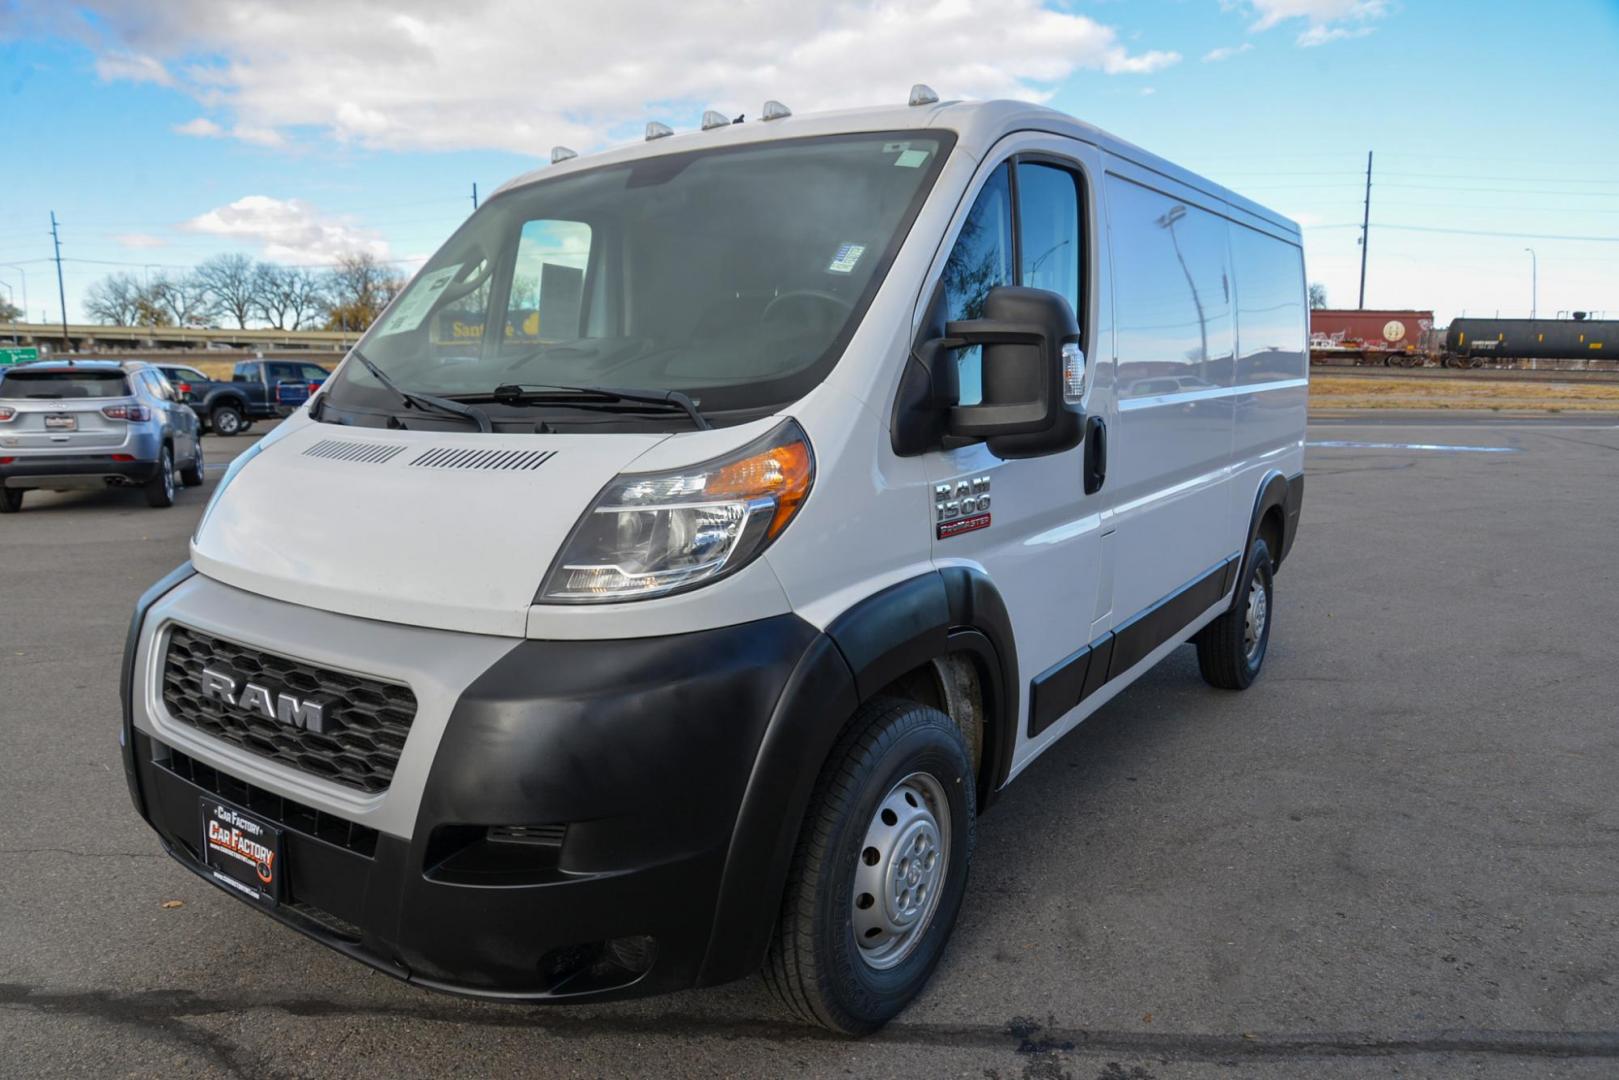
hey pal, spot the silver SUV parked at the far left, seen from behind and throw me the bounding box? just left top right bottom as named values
left=0, top=359, right=202, bottom=513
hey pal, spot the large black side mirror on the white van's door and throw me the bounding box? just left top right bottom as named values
left=929, top=285, right=1085, bottom=458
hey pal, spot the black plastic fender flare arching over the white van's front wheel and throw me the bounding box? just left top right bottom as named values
left=696, top=567, right=1018, bottom=986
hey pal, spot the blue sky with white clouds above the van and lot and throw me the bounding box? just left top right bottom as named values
left=0, top=0, right=1619, bottom=324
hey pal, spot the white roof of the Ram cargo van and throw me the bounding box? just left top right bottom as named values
left=495, top=100, right=1298, bottom=238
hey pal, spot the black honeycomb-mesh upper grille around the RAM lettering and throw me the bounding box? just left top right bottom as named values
left=164, top=627, right=416, bottom=792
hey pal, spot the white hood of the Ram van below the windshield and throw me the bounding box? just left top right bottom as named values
left=191, top=419, right=669, bottom=636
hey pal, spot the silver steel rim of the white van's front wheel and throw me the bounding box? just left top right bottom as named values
left=850, top=772, right=950, bottom=972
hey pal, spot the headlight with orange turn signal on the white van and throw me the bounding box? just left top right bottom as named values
left=538, top=421, right=814, bottom=604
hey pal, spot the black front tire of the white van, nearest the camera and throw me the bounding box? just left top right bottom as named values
left=764, top=699, right=978, bottom=1035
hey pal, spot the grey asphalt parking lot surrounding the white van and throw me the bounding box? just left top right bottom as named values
left=0, top=416, right=1619, bottom=1080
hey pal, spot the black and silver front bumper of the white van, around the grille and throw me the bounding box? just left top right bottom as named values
left=123, top=578, right=848, bottom=999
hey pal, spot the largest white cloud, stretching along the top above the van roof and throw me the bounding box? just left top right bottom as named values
left=57, top=0, right=1180, bottom=154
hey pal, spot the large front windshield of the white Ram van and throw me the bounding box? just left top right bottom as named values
left=327, top=131, right=950, bottom=423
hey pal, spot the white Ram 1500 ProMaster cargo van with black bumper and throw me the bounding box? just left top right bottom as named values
left=123, top=92, right=1307, bottom=1033
